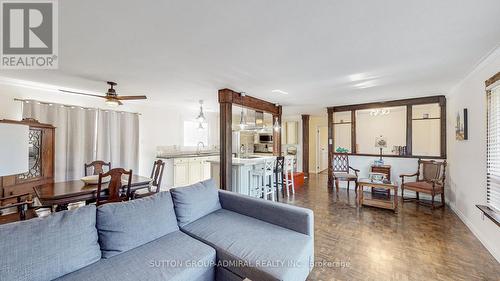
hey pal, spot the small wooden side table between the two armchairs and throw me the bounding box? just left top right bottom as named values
left=358, top=179, right=398, bottom=213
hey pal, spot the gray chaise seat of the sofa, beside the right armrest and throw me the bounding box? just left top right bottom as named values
left=181, top=209, right=314, bottom=280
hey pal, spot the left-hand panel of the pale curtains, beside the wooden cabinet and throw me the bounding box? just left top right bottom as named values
left=23, top=101, right=97, bottom=181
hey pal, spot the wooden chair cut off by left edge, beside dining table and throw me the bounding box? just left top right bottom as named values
left=0, top=193, right=36, bottom=224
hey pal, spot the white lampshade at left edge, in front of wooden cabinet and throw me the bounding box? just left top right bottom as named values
left=0, top=123, right=29, bottom=177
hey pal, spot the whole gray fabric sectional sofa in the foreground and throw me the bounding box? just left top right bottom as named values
left=0, top=180, right=314, bottom=281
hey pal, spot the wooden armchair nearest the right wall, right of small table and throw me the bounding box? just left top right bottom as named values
left=399, top=160, right=446, bottom=209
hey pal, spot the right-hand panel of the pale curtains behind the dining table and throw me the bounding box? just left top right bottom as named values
left=97, top=109, right=139, bottom=174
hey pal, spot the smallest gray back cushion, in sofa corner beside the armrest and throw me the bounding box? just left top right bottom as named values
left=171, top=179, right=221, bottom=227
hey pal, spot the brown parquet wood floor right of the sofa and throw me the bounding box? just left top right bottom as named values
left=284, top=174, right=500, bottom=281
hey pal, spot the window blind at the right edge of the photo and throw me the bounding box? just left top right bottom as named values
left=486, top=86, right=500, bottom=211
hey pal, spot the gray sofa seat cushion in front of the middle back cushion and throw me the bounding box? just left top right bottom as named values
left=57, top=231, right=215, bottom=281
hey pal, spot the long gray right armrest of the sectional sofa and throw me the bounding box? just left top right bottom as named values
left=219, top=190, right=314, bottom=236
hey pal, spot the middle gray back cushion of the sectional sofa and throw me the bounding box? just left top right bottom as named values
left=96, top=192, right=179, bottom=258
